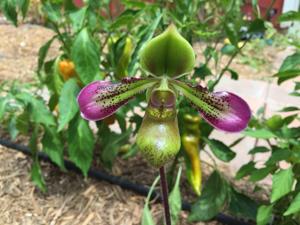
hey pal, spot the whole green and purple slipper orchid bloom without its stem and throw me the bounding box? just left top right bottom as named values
left=78, top=25, right=251, bottom=167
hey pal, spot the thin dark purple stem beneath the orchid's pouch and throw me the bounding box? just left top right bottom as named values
left=159, top=166, right=171, bottom=225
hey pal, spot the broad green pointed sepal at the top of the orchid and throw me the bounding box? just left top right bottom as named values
left=140, top=24, right=195, bottom=77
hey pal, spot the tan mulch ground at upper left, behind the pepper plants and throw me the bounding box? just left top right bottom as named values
left=0, top=24, right=58, bottom=82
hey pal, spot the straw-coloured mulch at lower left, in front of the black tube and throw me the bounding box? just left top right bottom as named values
left=0, top=144, right=220, bottom=225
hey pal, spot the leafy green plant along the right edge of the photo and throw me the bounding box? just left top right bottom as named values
left=236, top=12, right=300, bottom=225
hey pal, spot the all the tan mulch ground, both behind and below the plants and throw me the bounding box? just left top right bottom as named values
left=0, top=17, right=287, bottom=225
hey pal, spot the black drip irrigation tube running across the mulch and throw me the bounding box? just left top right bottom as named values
left=0, top=138, right=255, bottom=225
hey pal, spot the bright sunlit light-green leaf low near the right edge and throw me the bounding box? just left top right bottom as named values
left=271, top=167, right=294, bottom=203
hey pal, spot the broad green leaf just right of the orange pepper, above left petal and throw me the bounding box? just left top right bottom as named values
left=71, top=28, right=100, bottom=84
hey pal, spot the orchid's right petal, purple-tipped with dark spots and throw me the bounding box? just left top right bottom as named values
left=174, top=81, right=251, bottom=132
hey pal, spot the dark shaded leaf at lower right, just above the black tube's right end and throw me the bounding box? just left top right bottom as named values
left=229, top=188, right=258, bottom=220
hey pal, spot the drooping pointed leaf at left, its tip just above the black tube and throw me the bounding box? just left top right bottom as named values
left=42, top=127, right=65, bottom=170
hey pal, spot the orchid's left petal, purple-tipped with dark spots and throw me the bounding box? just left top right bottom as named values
left=77, top=78, right=155, bottom=121
